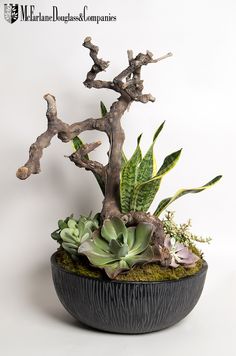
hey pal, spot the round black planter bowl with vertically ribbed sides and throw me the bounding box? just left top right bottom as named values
left=51, top=253, right=207, bottom=334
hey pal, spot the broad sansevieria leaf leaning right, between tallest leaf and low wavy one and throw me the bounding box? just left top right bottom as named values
left=131, top=150, right=181, bottom=211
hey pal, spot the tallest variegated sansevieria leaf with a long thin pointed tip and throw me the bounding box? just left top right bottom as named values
left=137, top=121, right=165, bottom=183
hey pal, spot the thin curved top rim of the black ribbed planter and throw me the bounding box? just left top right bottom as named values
left=50, top=251, right=208, bottom=285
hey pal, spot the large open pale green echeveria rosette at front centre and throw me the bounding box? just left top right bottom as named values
left=78, top=217, right=153, bottom=278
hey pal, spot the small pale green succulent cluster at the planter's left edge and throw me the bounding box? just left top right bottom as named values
left=51, top=215, right=99, bottom=259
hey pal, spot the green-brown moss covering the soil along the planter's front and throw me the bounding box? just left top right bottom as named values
left=56, top=247, right=203, bottom=281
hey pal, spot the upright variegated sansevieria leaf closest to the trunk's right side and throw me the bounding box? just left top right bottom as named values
left=120, top=135, right=142, bottom=213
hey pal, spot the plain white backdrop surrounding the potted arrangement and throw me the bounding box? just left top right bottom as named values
left=0, top=0, right=236, bottom=356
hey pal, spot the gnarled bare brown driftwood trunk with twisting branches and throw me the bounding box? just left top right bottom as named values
left=17, top=37, right=171, bottom=225
